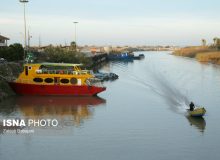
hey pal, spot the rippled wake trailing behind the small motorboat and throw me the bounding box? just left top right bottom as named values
left=111, top=64, right=190, bottom=114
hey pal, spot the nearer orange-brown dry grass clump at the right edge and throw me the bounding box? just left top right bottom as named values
left=196, top=51, right=220, bottom=64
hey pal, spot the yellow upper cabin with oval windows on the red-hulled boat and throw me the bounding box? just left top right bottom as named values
left=16, top=63, right=94, bottom=85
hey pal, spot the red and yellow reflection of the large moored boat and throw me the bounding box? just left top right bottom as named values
left=0, top=96, right=106, bottom=133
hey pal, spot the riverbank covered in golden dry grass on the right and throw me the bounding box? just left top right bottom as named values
left=173, top=46, right=220, bottom=65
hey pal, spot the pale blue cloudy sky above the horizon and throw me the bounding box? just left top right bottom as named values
left=0, top=0, right=220, bottom=46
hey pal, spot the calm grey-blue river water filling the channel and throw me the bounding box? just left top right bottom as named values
left=0, top=52, right=220, bottom=160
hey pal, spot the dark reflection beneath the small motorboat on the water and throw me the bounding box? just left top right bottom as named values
left=186, top=116, right=206, bottom=132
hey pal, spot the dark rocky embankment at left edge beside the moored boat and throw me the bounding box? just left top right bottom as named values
left=0, top=62, right=22, bottom=102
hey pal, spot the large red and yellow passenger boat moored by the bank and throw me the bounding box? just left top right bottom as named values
left=9, top=63, right=106, bottom=96
